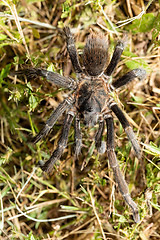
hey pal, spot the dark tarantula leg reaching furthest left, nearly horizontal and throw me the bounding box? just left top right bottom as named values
left=11, top=68, right=77, bottom=90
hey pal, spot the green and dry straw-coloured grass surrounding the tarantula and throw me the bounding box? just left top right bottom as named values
left=0, top=0, right=160, bottom=240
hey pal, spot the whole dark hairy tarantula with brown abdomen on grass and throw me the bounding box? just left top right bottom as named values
left=16, top=27, right=146, bottom=222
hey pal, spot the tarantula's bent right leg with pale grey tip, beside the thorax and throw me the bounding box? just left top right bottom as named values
left=112, top=68, right=146, bottom=89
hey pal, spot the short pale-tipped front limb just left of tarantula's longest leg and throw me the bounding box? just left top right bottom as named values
left=95, top=118, right=106, bottom=154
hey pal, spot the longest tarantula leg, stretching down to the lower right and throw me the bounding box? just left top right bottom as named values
left=105, top=114, right=140, bottom=223
